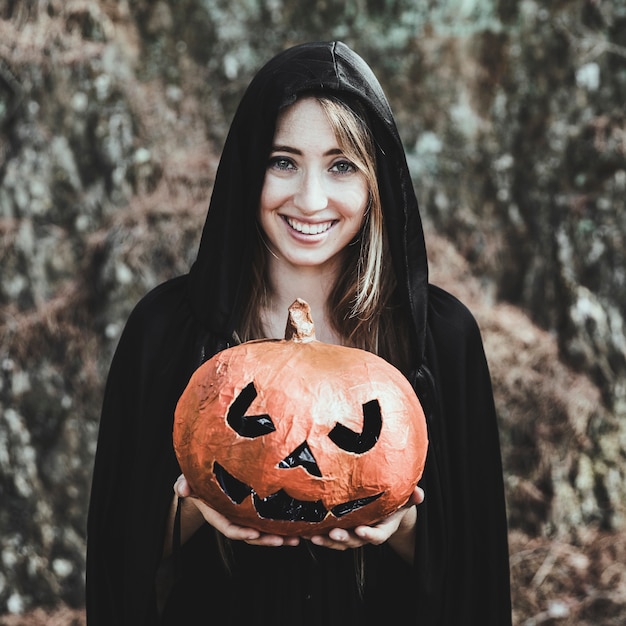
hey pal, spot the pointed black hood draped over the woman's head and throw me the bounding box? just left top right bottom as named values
left=189, top=42, right=428, bottom=366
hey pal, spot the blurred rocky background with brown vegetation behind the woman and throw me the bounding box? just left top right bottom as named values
left=0, top=0, right=626, bottom=626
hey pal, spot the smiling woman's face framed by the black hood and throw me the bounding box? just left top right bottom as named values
left=259, top=98, right=369, bottom=268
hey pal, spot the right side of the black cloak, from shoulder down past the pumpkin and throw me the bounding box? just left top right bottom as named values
left=415, top=285, right=511, bottom=626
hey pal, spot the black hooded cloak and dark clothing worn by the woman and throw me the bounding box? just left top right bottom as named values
left=86, top=43, right=511, bottom=626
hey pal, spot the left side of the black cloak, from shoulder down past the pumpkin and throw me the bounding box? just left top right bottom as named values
left=86, top=276, right=202, bottom=626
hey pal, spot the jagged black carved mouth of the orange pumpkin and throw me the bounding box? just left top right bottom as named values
left=213, top=462, right=383, bottom=523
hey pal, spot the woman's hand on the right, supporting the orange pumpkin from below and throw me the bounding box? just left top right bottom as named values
left=304, top=487, right=424, bottom=563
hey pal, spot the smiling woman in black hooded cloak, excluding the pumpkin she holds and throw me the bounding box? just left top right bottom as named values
left=87, top=42, right=511, bottom=626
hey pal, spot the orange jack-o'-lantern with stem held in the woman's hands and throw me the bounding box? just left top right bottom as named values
left=173, top=300, right=428, bottom=537
